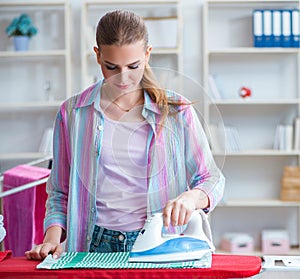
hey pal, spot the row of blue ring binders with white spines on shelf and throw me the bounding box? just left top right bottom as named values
left=252, top=9, right=300, bottom=48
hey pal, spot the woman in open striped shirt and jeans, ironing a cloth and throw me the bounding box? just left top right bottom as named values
left=26, top=11, right=224, bottom=259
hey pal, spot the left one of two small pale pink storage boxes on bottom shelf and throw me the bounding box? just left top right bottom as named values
left=221, top=233, right=254, bottom=254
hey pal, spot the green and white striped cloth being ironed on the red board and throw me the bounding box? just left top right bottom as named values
left=37, top=252, right=212, bottom=269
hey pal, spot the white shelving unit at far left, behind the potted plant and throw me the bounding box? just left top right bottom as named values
left=0, top=1, right=72, bottom=173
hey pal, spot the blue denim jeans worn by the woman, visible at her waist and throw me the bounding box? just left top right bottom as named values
left=90, top=225, right=140, bottom=253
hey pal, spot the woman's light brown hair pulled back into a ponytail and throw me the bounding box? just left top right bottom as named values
left=96, top=10, right=186, bottom=124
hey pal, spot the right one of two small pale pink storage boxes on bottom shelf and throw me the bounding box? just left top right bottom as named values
left=262, top=230, right=290, bottom=254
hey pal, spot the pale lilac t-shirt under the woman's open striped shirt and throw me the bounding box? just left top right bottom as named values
left=96, top=117, right=149, bottom=231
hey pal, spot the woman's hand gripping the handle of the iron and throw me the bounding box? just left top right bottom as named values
left=163, top=189, right=209, bottom=230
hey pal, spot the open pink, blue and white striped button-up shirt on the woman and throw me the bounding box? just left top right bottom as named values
left=44, top=81, right=225, bottom=251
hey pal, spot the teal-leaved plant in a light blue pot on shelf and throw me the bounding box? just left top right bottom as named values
left=6, top=14, right=38, bottom=51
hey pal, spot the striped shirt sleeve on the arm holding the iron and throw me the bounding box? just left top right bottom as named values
left=184, top=106, right=225, bottom=211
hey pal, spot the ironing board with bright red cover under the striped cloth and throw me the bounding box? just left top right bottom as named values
left=0, top=254, right=261, bottom=279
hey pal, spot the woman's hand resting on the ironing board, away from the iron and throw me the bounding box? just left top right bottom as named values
left=25, top=242, right=63, bottom=260
